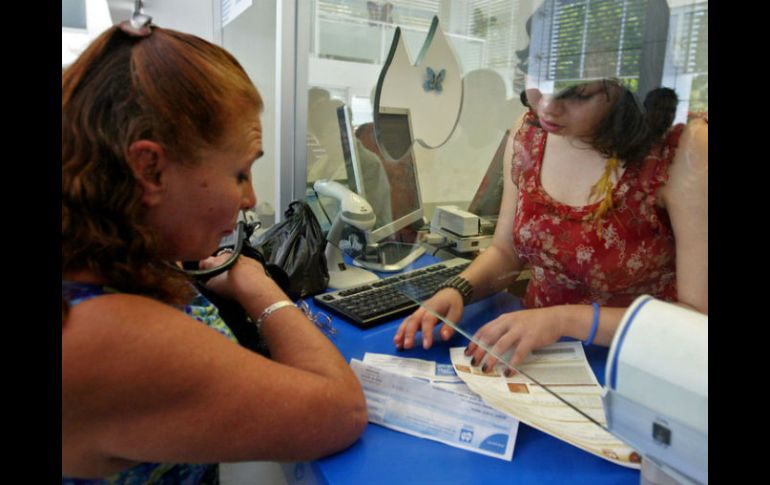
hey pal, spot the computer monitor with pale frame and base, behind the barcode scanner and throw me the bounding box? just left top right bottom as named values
left=337, top=106, right=423, bottom=271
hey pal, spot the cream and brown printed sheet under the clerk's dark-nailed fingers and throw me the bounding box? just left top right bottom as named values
left=450, top=342, right=641, bottom=469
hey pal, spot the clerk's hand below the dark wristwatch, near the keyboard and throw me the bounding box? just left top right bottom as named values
left=393, top=288, right=463, bottom=350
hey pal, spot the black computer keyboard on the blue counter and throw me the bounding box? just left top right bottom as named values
left=313, top=258, right=470, bottom=329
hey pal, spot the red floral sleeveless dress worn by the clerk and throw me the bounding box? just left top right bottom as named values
left=511, top=115, right=684, bottom=308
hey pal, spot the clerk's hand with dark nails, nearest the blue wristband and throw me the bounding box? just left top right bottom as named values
left=465, top=307, right=564, bottom=372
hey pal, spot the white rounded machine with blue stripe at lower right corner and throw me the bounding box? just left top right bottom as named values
left=602, top=295, right=708, bottom=485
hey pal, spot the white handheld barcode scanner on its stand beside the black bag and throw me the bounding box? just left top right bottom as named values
left=313, top=180, right=379, bottom=290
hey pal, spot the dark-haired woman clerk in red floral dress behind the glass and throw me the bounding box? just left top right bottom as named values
left=394, top=79, right=708, bottom=366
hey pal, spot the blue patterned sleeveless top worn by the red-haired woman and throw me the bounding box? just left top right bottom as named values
left=61, top=281, right=238, bottom=485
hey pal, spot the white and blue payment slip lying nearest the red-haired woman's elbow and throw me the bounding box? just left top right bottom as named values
left=350, top=355, right=519, bottom=461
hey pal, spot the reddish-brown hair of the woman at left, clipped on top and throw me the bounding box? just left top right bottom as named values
left=62, top=26, right=262, bottom=312
